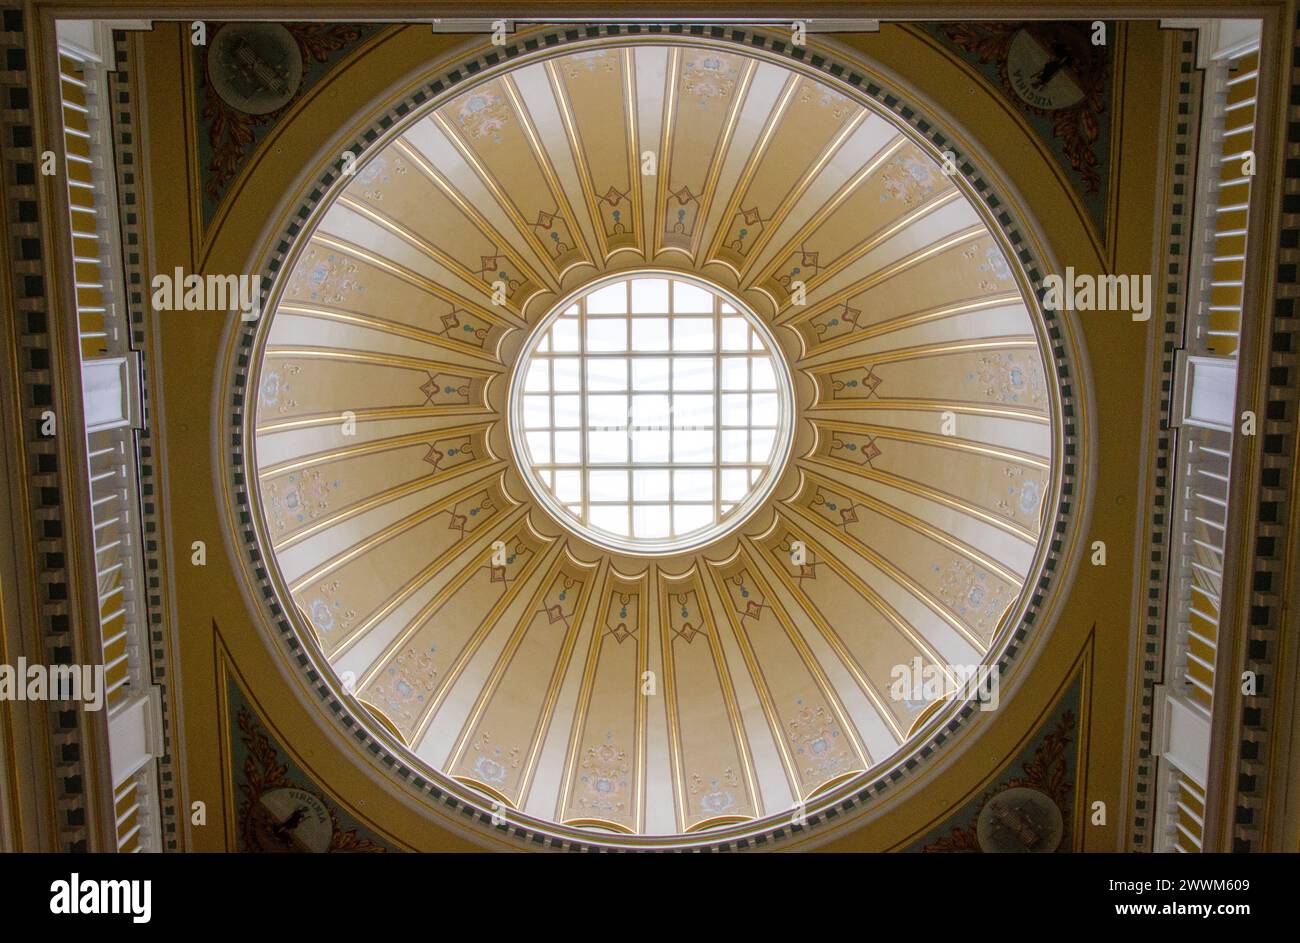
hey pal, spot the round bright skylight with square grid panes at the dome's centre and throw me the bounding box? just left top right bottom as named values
left=510, top=272, right=793, bottom=554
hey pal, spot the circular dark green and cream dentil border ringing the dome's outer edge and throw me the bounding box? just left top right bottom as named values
left=228, top=23, right=1080, bottom=852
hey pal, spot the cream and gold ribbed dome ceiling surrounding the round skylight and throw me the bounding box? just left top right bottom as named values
left=241, top=39, right=1058, bottom=844
